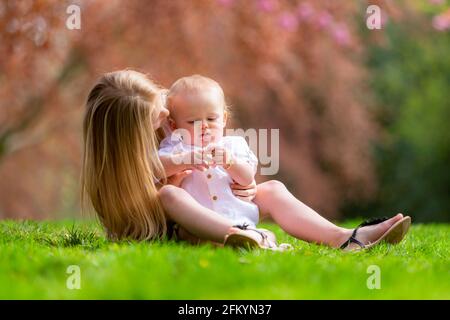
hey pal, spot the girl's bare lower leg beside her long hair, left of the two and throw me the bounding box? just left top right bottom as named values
left=159, top=185, right=235, bottom=243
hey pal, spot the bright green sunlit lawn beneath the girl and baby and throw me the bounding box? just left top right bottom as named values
left=0, top=221, right=450, bottom=299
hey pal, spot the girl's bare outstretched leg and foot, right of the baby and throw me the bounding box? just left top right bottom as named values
left=253, top=180, right=402, bottom=247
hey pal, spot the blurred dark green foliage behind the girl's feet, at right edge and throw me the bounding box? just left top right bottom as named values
left=350, top=24, right=450, bottom=221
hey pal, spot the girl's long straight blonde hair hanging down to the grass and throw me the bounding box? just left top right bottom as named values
left=81, top=70, right=167, bottom=240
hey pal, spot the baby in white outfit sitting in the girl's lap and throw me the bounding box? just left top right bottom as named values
left=159, top=75, right=259, bottom=228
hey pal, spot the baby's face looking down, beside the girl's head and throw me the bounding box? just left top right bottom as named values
left=170, top=90, right=227, bottom=147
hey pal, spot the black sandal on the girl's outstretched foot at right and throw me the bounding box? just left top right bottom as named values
left=340, top=216, right=411, bottom=250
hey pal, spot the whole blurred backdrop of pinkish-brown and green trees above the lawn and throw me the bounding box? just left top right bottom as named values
left=0, top=0, right=450, bottom=221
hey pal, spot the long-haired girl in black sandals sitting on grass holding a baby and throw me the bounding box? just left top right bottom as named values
left=82, top=70, right=410, bottom=248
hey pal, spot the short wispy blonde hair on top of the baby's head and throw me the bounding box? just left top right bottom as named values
left=167, top=74, right=229, bottom=112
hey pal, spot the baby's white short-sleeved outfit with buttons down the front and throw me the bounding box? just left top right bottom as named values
left=159, top=135, right=259, bottom=227
